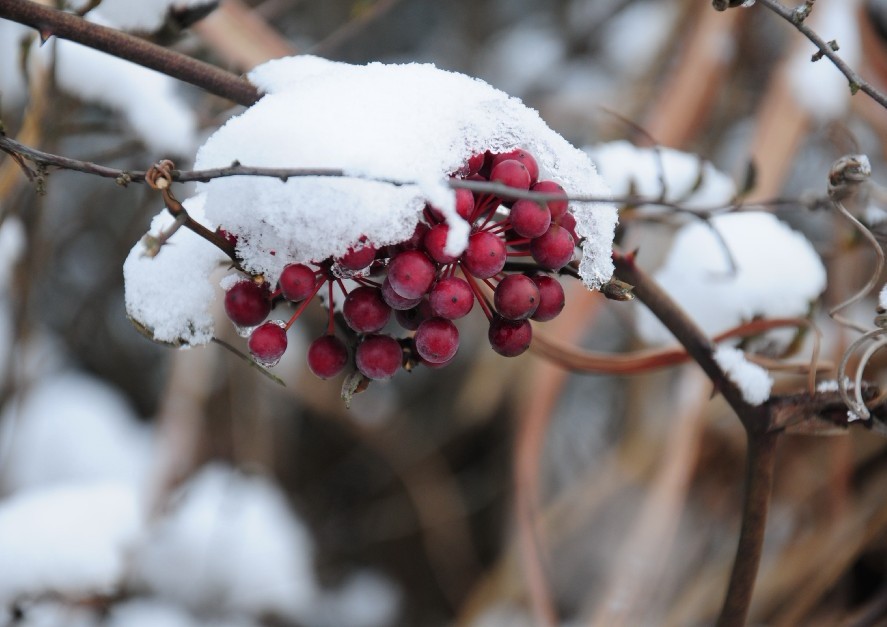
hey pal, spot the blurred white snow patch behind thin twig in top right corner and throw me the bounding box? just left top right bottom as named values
left=788, top=0, right=862, bottom=122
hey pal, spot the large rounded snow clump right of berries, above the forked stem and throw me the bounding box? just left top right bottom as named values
left=637, top=212, right=826, bottom=344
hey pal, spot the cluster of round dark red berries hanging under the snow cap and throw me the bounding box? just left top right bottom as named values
left=224, top=149, right=578, bottom=379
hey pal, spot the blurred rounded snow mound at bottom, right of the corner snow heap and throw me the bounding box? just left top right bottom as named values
left=135, top=464, right=317, bottom=618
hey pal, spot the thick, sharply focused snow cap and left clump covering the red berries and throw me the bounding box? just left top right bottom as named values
left=126, top=56, right=616, bottom=344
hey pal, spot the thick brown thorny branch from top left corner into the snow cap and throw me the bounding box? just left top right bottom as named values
left=0, top=0, right=261, bottom=107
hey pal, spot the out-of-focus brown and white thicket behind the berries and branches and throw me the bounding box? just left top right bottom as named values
left=0, top=0, right=887, bottom=627
